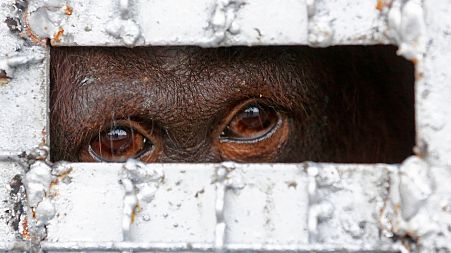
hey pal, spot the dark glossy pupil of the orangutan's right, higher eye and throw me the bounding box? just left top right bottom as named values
left=238, top=106, right=271, bottom=131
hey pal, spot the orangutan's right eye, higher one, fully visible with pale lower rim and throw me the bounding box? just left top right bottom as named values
left=220, top=104, right=282, bottom=142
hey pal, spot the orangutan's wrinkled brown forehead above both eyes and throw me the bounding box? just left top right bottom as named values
left=52, top=47, right=318, bottom=130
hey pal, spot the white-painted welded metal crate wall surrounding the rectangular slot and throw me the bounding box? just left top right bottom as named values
left=0, top=0, right=451, bottom=252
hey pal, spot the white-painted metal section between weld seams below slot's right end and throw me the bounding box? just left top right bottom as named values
left=316, top=165, right=390, bottom=246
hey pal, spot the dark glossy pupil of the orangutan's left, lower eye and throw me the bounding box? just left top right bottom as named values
left=100, top=127, right=133, bottom=155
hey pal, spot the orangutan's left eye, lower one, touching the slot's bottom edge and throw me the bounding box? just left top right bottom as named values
left=88, top=126, right=153, bottom=162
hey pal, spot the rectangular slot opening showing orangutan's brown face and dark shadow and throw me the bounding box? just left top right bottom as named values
left=50, top=46, right=415, bottom=163
